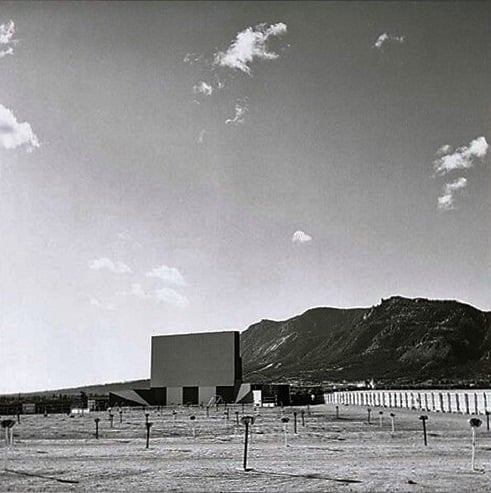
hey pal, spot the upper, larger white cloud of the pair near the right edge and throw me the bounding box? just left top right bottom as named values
left=433, top=137, right=489, bottom=175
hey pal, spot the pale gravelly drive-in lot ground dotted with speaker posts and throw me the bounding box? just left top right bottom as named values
left=0, top=405, right=491, bottom=492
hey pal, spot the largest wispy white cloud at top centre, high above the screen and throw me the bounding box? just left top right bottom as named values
left=214, top=22, right=287, bottom=76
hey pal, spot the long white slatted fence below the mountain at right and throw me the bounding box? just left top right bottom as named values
left=324, top=390, right=491, bottom=414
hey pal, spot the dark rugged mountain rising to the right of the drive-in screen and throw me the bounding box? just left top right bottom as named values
left=241, top=296, right=491, bottom=383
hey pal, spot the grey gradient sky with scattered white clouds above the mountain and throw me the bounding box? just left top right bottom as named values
left=0, top=1, right=491, bottom=393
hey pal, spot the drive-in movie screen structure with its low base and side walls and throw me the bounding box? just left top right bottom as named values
left=109, top=332, right=291, bottom=406
